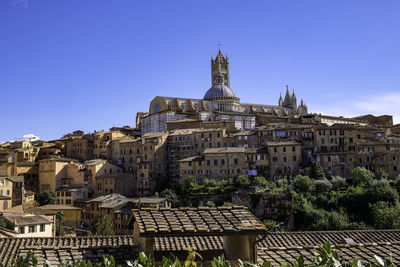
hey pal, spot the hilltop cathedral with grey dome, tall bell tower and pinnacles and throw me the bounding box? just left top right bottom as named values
left=141, top=50, right=308, bottom=134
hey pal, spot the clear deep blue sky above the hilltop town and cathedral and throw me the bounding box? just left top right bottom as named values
left=0, top=0, right=400, bottom=141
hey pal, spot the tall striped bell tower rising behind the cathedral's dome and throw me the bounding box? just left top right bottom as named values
left=211, top=49, right=230, bottom=87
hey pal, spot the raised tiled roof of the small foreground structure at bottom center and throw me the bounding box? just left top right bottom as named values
left=133, top=206, right=267, bottom=237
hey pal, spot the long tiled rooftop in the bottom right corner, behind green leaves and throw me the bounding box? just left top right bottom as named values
left=257, top=230, right=400, bottom=266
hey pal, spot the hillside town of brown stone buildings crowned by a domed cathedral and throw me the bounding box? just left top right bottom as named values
left=0, top=50, right=400, bottom=266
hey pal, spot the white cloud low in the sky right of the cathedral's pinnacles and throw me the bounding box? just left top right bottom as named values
left=310, top=93, right=400, bottom=124
